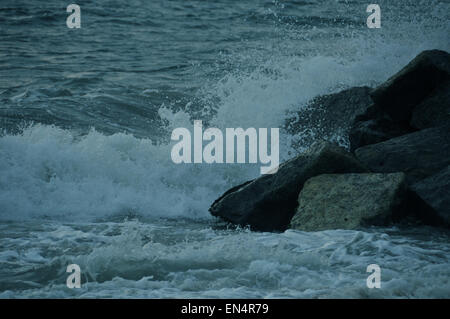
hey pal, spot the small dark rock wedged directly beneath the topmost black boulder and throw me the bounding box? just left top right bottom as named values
left=349, top=105, right=414, bottom=152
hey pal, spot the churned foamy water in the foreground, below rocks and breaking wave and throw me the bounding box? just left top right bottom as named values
left=0, top=221, right=450, bottom=298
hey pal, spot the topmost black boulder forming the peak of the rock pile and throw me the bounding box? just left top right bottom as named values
left=371, top=50, right=450, bottom=123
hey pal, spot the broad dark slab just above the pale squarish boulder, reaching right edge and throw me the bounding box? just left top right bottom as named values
left=355, top=125, right=450, bottom=183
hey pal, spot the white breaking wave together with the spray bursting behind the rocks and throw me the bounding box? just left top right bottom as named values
left=0, top=23, right=449, bottom=220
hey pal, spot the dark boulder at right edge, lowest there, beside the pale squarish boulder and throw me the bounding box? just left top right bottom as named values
left=411, top=166, right=450, bottom=226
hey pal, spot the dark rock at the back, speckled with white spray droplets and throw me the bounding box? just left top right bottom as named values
left=286, top=87, right=373, bottom=151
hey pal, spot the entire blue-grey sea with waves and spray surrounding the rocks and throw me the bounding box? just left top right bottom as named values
left=0, top=0, right=450, bottom=298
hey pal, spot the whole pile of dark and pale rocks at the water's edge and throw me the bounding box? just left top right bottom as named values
left=210, top=50, right=450, bottom=231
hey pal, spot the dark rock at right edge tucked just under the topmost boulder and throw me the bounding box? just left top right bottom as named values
left=411, top=81, right=450, bottom=129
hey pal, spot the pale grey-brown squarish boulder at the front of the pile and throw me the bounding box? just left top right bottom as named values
left=290, top=173, right=408, bottom=231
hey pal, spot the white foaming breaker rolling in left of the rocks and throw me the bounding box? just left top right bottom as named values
left=0, top=125, right=258, bottom=221
